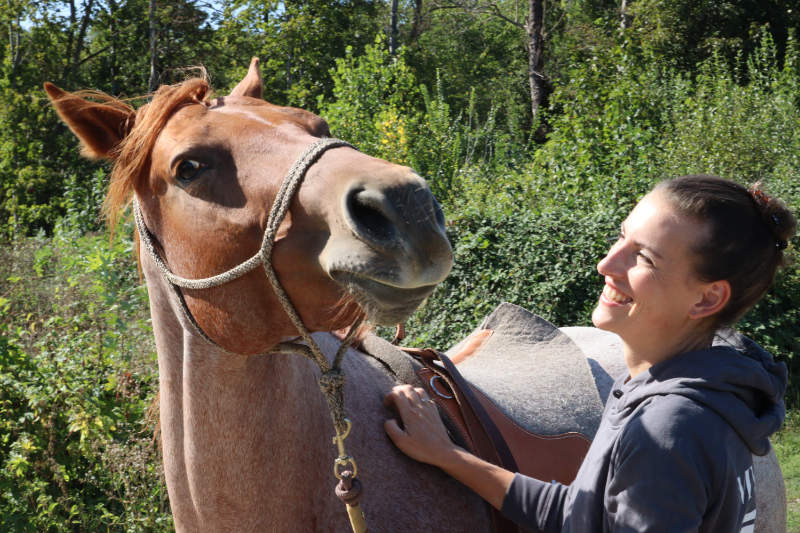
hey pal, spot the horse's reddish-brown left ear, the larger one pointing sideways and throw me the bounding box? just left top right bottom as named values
left=44, top=82, right=136, bottom=159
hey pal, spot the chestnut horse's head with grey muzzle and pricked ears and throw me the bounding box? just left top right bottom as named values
left=45, top=58, right=453, bottom=354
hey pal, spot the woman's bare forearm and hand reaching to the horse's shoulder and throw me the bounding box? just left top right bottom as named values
left=384, top=385, right=514, bottom=509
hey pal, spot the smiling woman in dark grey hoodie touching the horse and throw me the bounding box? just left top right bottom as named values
left=385, top=176, right=796, bottom=532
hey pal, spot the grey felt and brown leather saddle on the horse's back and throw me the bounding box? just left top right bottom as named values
left=362, top=303, right=602, bottom=533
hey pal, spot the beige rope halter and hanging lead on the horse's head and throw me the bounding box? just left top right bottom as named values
left=133, top=138, right=368, bottom=533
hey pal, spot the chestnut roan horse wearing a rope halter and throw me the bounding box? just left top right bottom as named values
left=45, top=58, right=785, bottom=532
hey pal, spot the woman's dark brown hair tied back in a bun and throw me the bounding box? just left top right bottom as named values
left=654, top=175, right=797, bottom=329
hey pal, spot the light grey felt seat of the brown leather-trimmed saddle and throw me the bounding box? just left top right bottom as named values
left=447, top=303, right=603, bottom=438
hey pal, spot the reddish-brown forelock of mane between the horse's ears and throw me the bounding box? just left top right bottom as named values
left=103, top=75, right=211, bottom=231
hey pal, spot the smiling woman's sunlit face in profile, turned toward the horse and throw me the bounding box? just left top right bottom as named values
left=592, top=191, right=708, bottom=350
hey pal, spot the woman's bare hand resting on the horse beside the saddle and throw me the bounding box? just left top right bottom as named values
left=383, top=385, right=460, bottom=468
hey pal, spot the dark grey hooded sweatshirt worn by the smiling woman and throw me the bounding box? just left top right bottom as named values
left=502, top=334, right=787, bottom=533
